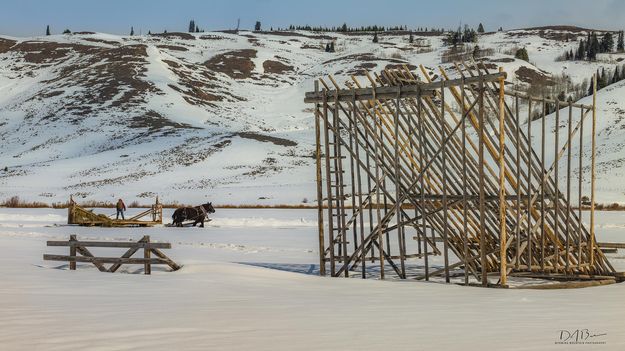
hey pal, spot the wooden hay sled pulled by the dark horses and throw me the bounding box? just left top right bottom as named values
left=67, top=197, right=163, bottom=227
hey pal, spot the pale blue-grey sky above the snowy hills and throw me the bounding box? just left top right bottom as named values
left=0, top=0, right=625, bottom=36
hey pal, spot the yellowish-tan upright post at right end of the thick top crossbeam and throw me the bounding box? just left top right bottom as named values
left=499, top=67, right=508, bottom=285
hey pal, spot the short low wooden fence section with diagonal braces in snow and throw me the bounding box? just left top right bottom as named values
left=43, top=235, right=180, bottom=274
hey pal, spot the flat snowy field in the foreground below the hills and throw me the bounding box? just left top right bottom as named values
left=0, top=208, right=625, bottom=350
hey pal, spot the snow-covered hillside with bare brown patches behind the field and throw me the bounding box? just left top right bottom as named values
left=0, top=28, right=625, bottom=204
